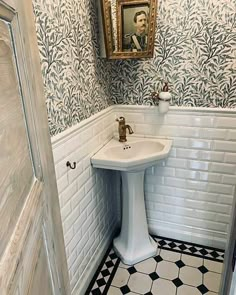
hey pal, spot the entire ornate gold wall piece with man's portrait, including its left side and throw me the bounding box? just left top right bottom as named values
left=101, top=0, right=157, bottom=59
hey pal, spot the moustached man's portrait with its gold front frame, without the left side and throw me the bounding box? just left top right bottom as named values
left=117, top=0, right=156, bottom=58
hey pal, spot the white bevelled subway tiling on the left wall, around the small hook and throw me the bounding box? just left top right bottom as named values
left=52, top=109, right=118, bottom=294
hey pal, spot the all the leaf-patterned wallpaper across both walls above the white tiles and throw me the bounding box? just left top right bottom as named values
left=33, top=0, right=236, bottom=136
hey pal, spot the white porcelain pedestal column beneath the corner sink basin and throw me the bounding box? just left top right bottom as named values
left=113, top=170, right=157, bottom=265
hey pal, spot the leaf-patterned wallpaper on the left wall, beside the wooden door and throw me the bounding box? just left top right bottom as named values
left=33, top=0, right=112, bottom=136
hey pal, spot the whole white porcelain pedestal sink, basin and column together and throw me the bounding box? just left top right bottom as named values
left=91, top=136, right=172, bottom=265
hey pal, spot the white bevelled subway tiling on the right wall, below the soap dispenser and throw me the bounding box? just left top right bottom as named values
left=114, top=105, right=236, bottom=248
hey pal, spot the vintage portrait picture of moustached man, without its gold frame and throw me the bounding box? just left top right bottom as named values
left=122, top=4, right=149, bottom=52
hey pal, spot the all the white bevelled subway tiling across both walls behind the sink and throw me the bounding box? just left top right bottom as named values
left=52, top=105, right=236, bottom=294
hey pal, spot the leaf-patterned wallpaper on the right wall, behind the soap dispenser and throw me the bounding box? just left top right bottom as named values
left=111, top=0, right=236, bottom=108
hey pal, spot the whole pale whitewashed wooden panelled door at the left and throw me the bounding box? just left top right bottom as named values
left=0, top=0, right=69, bottom=295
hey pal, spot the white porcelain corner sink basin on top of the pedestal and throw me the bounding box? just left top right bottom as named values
left=91, top=137, right=172, bottom=171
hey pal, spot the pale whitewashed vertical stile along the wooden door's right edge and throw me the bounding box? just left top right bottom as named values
left=0, top=0, right=70, bottom=295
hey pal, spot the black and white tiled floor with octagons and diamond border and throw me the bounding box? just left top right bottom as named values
left=86, top=237, right=224, bottom=295
